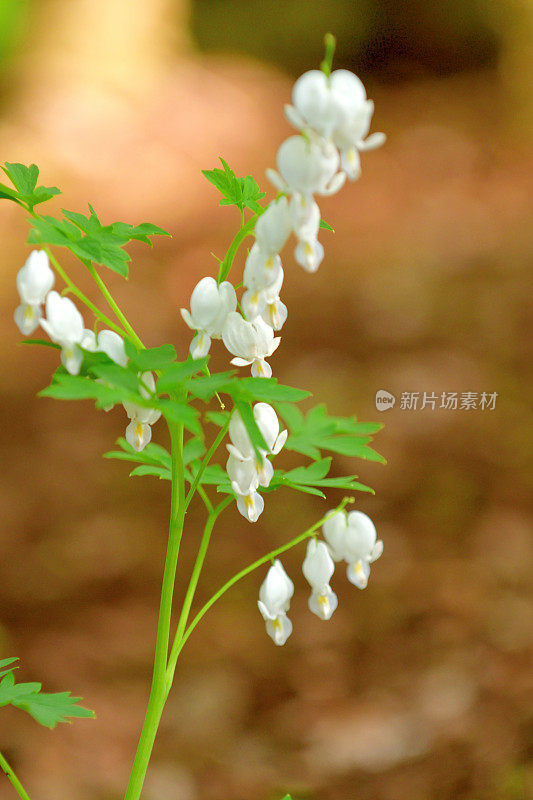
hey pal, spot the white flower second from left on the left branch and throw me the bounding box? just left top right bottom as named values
left=41, top=291, right=85, bottom=375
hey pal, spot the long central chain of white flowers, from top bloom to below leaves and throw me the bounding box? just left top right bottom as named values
left=181, top=65, right=385, bottom=522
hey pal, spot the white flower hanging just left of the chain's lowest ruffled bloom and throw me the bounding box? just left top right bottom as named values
left=181, top=277, right=237, bottom=358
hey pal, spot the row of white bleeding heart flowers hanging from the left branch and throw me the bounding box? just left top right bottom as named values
left=14, top=250, right=158, bottom=451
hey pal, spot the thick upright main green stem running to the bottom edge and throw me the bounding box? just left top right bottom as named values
left=125, top=423, right=185, bottom=800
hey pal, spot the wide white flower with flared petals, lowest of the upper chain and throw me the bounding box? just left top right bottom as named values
left=222, top=311, right=281, bottom=378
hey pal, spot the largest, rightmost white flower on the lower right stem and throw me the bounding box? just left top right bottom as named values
left=322, top=511, right=383, bottom=589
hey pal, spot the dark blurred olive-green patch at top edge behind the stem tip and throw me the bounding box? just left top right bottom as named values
left=191, top=0, right=499, bottom=78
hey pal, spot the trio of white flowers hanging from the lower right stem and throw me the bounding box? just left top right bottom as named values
left=257, top=511, right=383, bottom=645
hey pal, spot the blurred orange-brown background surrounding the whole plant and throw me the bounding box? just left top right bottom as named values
left=0, top=0, right=533, bottom=800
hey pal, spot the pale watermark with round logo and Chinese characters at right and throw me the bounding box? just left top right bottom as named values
left=376, top=389, right=498, bottom=411
